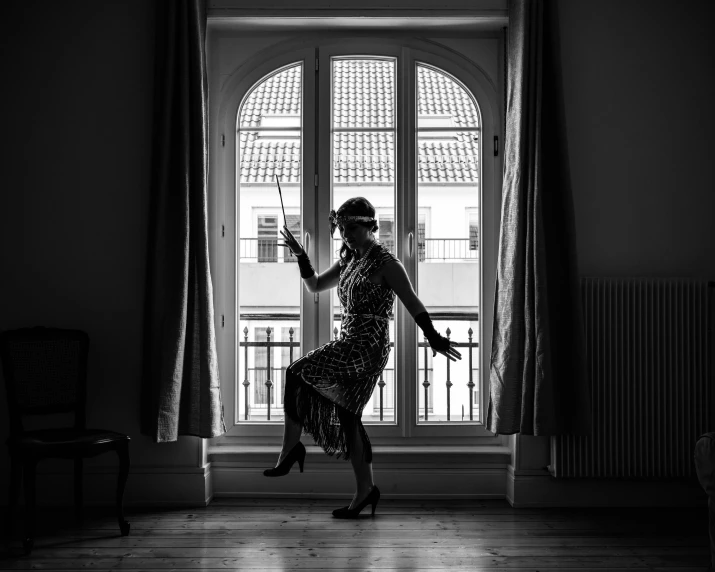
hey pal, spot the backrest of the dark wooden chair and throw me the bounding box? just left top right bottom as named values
left=0, top=327, right=89, bottom=433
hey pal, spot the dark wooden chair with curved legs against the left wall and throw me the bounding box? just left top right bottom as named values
left=0, top=327, right=129, bottom=554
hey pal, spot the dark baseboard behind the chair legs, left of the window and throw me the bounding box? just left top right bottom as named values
left=9, top=463, right=213, bottom=507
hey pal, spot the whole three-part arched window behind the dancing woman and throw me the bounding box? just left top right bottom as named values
left=211, top=34, right=500, bottom=443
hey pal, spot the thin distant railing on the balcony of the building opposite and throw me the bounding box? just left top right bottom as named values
left=239, top=238, right=479, bottom=262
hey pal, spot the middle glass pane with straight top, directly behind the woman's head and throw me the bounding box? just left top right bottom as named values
left=331, top=58, right=397, bottom=423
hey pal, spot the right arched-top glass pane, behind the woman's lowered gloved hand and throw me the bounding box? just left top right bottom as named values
left=415, top=65, right=481, bottom=423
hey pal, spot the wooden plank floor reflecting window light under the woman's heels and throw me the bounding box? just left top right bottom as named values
left=0, top=499, right=709, bottom=572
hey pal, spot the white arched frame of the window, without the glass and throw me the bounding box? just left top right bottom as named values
left=209, top=34, right=506, bottom=447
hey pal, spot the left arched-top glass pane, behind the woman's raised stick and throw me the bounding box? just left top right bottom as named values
left=236, top=65, right=302, bottom=423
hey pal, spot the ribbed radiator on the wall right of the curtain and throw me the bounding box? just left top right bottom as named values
left=549, top=278, right=715, bottom=479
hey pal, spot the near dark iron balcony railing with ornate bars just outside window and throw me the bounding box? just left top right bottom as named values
left=239, top=326, right=479, bottom=421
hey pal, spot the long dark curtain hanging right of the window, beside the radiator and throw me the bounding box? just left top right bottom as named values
left=487, top=0, right=591, bottom=435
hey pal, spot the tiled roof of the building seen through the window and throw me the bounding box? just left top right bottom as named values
left=240, top=58, right=479, bottom=184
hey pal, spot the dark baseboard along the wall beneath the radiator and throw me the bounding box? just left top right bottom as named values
left=506, top=465, right=707, bottom=508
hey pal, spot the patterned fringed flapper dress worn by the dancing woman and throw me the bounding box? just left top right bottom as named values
left=284, top=242, right=397, bottom=461
